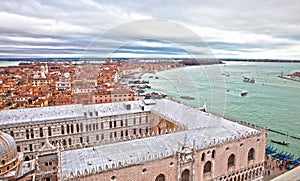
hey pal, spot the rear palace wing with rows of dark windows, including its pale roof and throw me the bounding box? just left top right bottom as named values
left=0, top=102, right=150, bottom=161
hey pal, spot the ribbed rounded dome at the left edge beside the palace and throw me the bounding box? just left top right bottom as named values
left=0, top=131, right=18, bottom=167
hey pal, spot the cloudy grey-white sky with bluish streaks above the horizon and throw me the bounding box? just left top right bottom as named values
left=0, top=0, right=300, bottom=59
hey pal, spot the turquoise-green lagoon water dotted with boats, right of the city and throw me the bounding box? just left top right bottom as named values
left=142, top=62, right=300, bottom=157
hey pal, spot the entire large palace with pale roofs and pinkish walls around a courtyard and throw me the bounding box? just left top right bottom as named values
left=0, top=99, right=266, bottom=181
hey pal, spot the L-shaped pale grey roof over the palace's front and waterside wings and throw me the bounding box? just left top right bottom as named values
left=61, top=99, right=259, bottom=176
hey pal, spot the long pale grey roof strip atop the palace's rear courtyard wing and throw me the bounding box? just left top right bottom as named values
left=0, top=101, right=145, bottom=126
